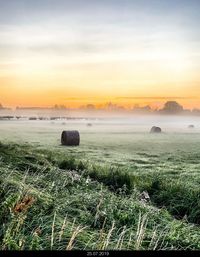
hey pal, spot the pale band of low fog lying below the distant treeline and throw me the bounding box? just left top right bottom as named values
left=0, top=110, right=200, bottom=133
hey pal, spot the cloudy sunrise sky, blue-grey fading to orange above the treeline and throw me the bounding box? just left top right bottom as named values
left=0, top=0, right=200, bottom=108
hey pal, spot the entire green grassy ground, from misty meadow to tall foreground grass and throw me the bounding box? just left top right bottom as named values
left=0, top=117, right=200, bottom=250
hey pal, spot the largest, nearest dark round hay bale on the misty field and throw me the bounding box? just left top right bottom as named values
left=61, top=130, right=80, bottom=145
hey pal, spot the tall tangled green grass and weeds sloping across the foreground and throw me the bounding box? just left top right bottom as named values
left=0, top=141, right=200, bottom=250
